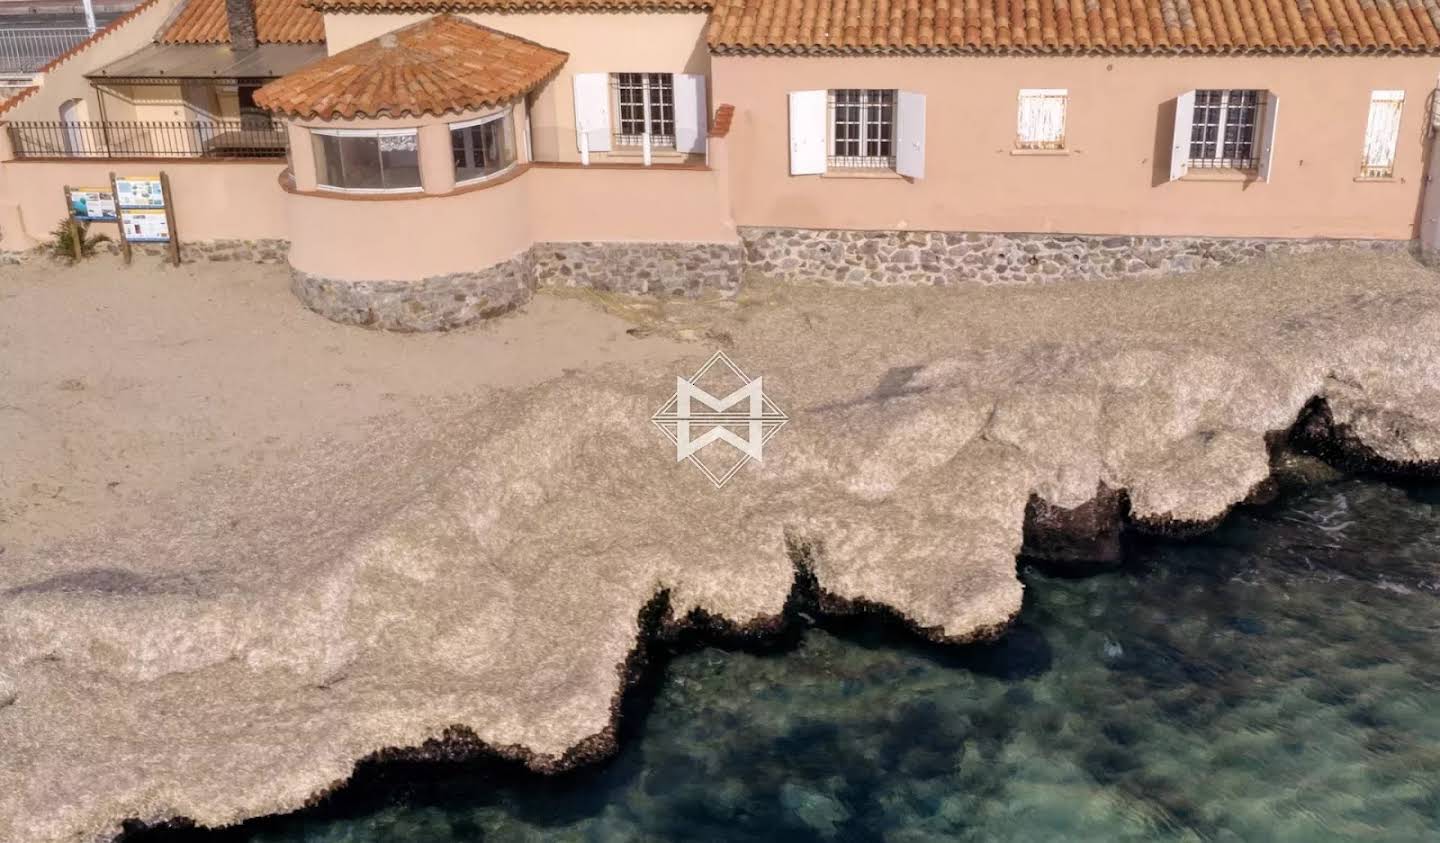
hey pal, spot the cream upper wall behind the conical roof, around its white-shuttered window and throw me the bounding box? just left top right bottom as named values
left=325, top=12, right=710, bottom=161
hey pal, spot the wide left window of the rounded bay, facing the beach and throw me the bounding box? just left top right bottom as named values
left=311, top=128, right=420, bottom=192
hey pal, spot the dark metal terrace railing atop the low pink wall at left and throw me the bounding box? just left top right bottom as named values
left=7, top=115, right=285, bottom=159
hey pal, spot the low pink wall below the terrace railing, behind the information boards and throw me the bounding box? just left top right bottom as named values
left=0, top=160, right=289, bottom=249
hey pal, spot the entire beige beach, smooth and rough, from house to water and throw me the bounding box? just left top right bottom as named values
left=0, top=255, right=1440, bottom=840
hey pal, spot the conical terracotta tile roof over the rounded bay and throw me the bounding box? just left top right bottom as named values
left=255, top=14, right=569, bottom=118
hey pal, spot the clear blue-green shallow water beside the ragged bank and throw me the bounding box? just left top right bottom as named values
left=135, top=481, right=1440, bottom=843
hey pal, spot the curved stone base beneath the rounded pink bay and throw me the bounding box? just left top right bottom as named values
left=289, top=251, right=534, bottom=331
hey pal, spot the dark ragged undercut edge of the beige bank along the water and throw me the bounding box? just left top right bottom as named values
left=118, top=398, right=1440, bottom=843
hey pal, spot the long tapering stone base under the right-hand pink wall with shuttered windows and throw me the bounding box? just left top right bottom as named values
left=740, top=228, right=1411, bottom=287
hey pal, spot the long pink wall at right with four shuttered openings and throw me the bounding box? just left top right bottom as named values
left=713, top=55, right=1440, bottom=239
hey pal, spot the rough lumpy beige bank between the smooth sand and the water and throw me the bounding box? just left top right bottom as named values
left=0, top=257, right=1440, bottom=842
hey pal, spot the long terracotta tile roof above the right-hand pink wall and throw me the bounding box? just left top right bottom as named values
left=708, top=0, right=1440, bottom=53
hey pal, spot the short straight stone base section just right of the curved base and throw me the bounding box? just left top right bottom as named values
left=531, top=242, right=744, bottom=295
